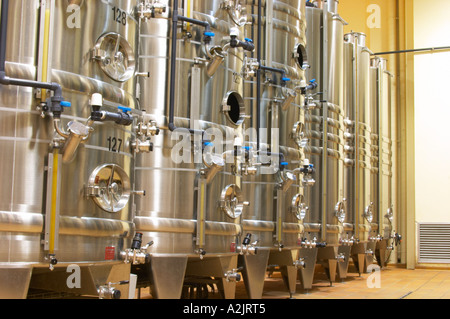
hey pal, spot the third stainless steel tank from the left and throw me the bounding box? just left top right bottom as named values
left=242, top=1, right=307, bottom=300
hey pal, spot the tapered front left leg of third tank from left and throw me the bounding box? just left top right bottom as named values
left=239, top=249, right=270, bottom=299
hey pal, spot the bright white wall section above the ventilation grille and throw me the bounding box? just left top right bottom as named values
left=414, top=0, right=450, bottom=223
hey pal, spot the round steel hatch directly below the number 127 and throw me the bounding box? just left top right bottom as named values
left=87, top=164, right=131, bottom=213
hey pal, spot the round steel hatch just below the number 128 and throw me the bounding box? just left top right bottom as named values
left=92, top=32, right=136, bottom=82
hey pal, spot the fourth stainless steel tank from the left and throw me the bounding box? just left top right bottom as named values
left=306, top=1, right=351, bottom=282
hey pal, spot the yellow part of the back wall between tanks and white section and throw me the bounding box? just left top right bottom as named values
left=339, top=0, right=414, bottom=268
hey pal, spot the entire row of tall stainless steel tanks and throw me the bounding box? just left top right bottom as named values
left=0, top=0, right=393, bottom=298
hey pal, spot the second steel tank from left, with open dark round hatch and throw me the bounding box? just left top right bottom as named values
left=134, top=0, right=254, bottom=298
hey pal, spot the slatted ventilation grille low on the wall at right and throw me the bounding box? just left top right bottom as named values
left=419, top=223, right=450, bottom=264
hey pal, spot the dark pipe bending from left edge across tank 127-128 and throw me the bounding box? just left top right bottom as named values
left=0, top=0, right=64, bottom=118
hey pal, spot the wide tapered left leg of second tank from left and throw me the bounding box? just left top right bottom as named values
left=150, top=256, right=188, bottom=299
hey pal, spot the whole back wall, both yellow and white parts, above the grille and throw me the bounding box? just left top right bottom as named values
left=339, top=0, right=450, bottom=268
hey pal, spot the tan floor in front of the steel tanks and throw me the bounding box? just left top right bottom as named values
left=136, top=265, right=450, bottom=299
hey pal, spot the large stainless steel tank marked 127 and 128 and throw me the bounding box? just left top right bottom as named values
left=0, top=0, right=138, bottom=298
